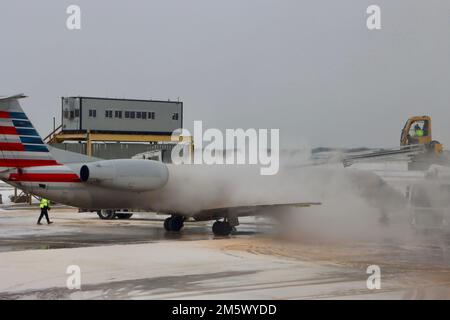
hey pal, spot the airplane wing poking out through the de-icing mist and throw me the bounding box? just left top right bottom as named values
left=192, top=202, right=321, bottom=221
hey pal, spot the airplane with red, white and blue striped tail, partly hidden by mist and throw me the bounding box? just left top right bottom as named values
left=0, top=94, right=320, bottom=236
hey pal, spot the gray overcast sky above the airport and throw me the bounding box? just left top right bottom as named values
left=0, top=0, right=450, bottom=147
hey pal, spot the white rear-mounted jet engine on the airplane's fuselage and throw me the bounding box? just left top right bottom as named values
left=80, top=159, right=169, bottom=191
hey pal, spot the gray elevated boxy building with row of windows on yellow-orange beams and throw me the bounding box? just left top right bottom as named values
left=49, top=96, right=188, bottom=162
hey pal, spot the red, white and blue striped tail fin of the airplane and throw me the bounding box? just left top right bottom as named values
left=0, top=94, right=58, bottom=168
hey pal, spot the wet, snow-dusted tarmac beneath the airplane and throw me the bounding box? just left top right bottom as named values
left=0, top=208, right=450, bottom=300
